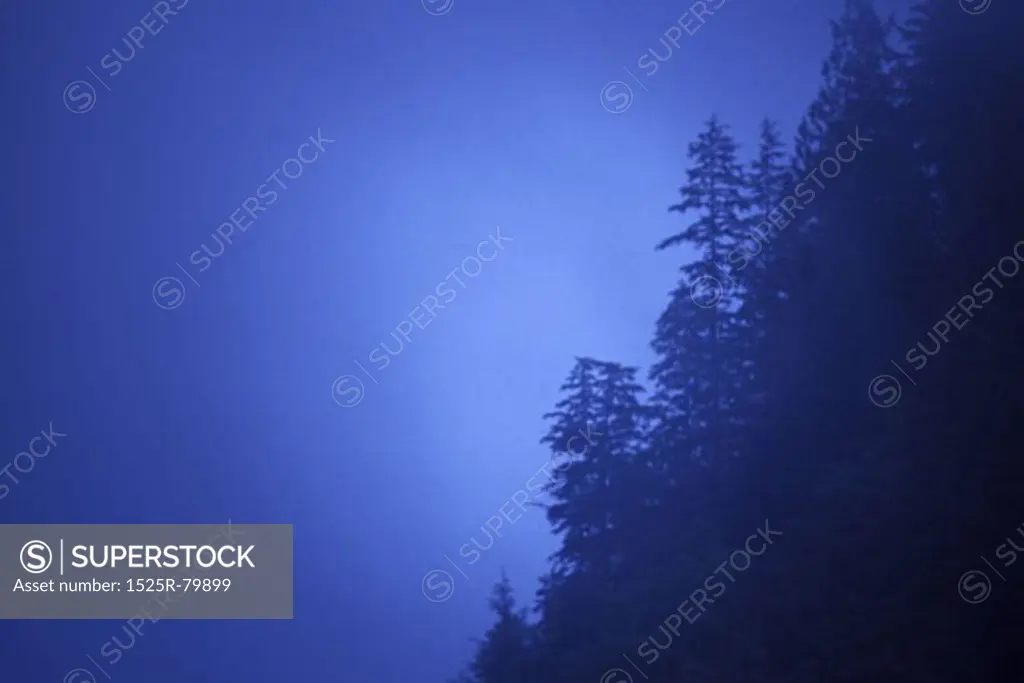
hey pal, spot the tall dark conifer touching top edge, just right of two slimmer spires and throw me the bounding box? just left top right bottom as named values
left=755, top=0, right=905, bottom=438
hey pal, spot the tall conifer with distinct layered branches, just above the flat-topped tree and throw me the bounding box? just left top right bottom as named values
left=650, top=117, right=750, bottom=482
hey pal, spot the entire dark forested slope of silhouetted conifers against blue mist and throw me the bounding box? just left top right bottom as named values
left=450, top=0, right=1024, bottom=683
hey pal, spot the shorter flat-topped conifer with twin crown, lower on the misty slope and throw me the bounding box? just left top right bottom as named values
left=539, top=357, right=657, bottom=680
